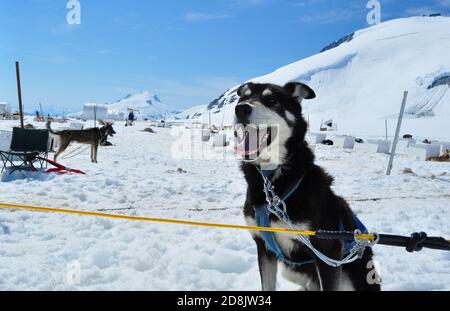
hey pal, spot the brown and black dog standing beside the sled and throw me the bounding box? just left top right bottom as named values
left=47, top=121, right=116, bottom=163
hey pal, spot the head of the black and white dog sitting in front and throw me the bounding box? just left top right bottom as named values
left=235, top=82, right=316, bottom=166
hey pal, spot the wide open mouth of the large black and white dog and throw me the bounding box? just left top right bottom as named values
left=234, top=124, right=277, bottom=158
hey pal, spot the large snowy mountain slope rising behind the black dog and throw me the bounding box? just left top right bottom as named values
left=178, top=17, right=450, bottom=139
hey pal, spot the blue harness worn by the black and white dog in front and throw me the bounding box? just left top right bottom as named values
left=254, top=171, right=368, bottom=266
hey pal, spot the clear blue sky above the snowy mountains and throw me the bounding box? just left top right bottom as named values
left=0, top=0, right=450, bottom=111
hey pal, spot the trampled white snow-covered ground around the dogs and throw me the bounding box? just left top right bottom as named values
left=0, top=121, right=450, bottom=290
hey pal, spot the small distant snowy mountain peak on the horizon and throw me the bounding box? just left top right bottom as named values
left=108, top=91, right=174, bottom=120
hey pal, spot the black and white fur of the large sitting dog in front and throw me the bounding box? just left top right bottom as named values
left=235, top=83, right=380, bottom=291
